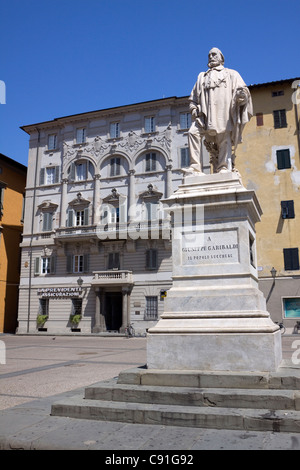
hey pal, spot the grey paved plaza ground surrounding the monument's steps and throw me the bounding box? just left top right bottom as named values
left=0, top=335, right=300, bottom=453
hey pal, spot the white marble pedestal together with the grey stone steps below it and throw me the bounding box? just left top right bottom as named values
left=51, top=173, right=290, bottom=432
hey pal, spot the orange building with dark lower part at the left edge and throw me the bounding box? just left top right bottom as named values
left=0, top=154, right=27, bottom=333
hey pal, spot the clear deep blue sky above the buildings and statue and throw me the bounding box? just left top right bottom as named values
left=0, top=0, right=300, bottom=165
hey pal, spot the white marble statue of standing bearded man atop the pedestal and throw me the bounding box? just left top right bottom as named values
left=187, top=48, right=253, bottom=174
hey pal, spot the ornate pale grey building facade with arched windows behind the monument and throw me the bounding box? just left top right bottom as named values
left=17, top=97, right=209, bottom=335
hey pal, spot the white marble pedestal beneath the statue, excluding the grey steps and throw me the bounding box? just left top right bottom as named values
left=147, top=173, right=282, bottom=371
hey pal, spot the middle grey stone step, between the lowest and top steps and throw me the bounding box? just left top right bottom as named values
left=85, top=380, right=300, bottom=410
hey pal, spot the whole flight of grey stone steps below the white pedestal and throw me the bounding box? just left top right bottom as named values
left=51, top=367, right=300, bottom=433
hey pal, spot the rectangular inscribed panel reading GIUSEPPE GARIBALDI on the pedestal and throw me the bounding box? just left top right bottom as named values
left=182, top=230, right=239, bottom=266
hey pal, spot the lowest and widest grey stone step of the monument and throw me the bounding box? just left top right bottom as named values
left=51, top=397, right=300, bottom=433
